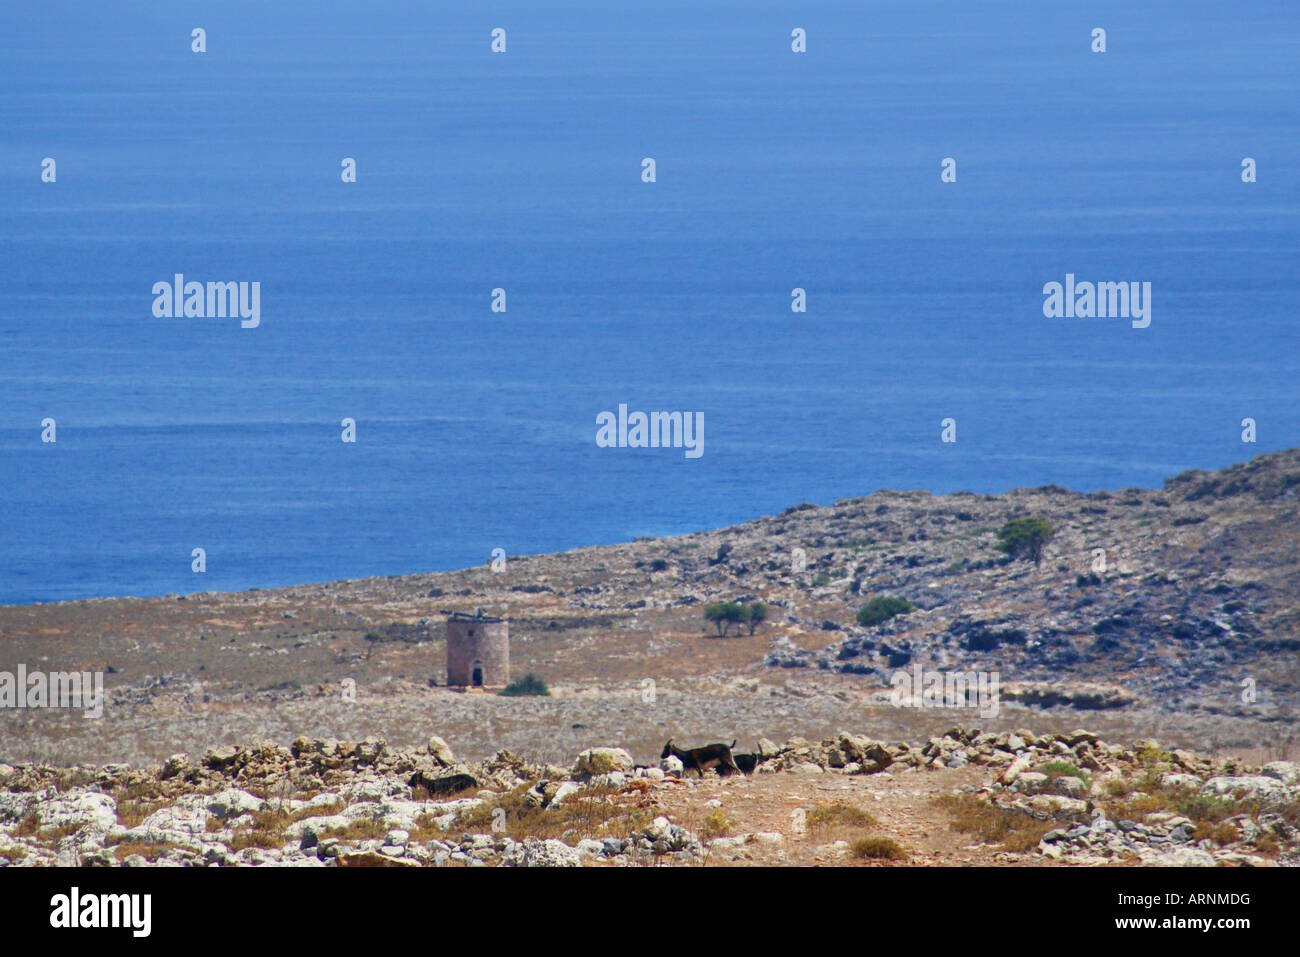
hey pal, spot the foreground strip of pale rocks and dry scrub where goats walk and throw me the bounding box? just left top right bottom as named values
left=0, top=727, right=1300, bottom=867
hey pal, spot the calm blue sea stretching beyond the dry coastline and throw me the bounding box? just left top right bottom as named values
left=0, top=0, right=1300, bottom=603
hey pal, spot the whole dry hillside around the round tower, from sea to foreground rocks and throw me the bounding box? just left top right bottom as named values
left=0, top=450, right=1300, bottom=765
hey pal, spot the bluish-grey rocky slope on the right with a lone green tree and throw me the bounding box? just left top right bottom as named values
left=754, top=450, right=1300, bottom=711
